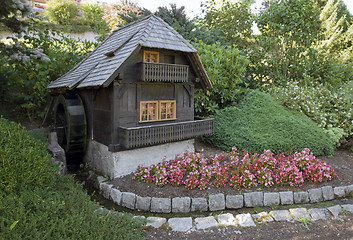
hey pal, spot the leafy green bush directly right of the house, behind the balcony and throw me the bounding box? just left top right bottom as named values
left=194, top=41, right=248, bottom=115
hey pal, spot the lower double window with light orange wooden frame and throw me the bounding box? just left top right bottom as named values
left=140, top=100, right=176, bottom=122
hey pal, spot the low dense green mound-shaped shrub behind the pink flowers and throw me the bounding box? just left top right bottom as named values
left=204, top=90, right=334, bottom=155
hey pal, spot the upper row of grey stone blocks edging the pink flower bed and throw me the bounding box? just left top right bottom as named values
left=97, top=176, right=353, bottom=213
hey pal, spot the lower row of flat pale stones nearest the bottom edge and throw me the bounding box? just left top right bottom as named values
left=95, top=204, right=353, bottom=232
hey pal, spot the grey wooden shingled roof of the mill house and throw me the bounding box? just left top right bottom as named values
left=48, top=15, right=212, bottom=89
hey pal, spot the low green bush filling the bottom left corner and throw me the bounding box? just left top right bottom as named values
left=0, top=117, right=144, bottom=240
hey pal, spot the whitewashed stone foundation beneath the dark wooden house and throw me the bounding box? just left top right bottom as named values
left=84, top=139, right=195, bottom=179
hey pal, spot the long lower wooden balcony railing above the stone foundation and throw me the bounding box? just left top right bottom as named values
left=120, top=118, right=213, bottom=149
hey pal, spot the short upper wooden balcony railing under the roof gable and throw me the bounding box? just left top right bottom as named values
left=141, top=62, right=189, bottom=82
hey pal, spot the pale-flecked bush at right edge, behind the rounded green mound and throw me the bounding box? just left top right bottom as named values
left=268, top=82, right=353, bottom=144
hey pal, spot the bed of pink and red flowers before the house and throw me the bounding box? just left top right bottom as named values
left=133, top=147, right=337, bottom=190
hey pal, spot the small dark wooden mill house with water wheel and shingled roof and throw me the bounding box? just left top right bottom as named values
left=48, top=15, right=213, bottom=178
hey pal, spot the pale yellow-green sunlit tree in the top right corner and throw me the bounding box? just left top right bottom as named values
left=313, top=0, right=353, bottom=85
